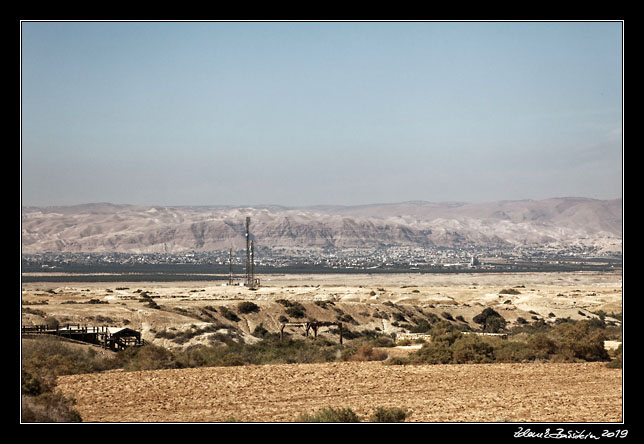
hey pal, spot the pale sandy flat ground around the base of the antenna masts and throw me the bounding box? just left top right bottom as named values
left=22, top=272, right=623, bottom=329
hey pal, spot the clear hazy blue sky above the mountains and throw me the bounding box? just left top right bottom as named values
left=21, top=22, right=623, bottom=205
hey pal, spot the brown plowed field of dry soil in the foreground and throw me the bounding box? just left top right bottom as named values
left=58, top=362, right=622, bottom=422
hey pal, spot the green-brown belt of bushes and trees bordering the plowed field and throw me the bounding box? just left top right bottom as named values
left=22, top=302, right=621, bottom=422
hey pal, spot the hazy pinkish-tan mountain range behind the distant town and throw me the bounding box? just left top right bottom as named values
left=21, top=197, right=623, bottom=254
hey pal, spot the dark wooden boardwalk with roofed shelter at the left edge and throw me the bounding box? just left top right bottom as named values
left=22, top=325, right=145, bottom=351
